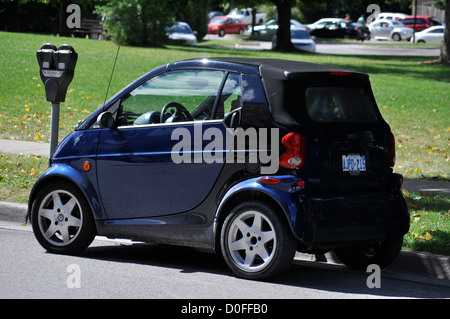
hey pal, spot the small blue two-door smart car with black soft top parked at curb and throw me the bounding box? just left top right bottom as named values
left=29, top=58, right=409, bottom=280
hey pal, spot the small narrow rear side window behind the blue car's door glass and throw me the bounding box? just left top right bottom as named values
left=215, top=73, right=242, bottom=119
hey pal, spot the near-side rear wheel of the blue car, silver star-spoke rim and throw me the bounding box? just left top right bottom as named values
left=221, top=201, right=297, bottom=280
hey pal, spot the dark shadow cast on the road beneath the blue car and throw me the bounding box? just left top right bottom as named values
left=80, top=244, right=450, bottom=298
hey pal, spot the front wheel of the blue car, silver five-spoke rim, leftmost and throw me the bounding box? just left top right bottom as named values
left=31, top=181, right=96, bottom=254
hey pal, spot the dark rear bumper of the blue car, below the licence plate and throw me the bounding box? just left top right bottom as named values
left=292, top=174, right=409, bottom=250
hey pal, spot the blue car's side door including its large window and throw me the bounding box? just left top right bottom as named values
left=97, top=70, right=241, bottom=219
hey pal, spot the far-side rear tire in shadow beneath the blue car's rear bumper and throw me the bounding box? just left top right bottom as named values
left=333, top=236, right=403, bottom=270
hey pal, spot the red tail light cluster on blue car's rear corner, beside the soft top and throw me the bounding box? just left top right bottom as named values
left=280, top=132, right=306, bottom=169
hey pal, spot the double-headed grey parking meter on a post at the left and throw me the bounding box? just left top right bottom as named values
left=36, top=43, right=78, bottom=156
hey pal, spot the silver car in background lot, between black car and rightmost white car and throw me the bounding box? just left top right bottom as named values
left=369, top=20, right=414, bottom=41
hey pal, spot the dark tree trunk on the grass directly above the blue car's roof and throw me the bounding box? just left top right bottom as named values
left=274, top=0, right=294, bottom=51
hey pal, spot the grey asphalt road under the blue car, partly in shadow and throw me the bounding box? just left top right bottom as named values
left=0, top=222, right=450, bottom=302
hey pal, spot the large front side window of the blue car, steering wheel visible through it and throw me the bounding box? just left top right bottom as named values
left=119, top=70, right=225, bottom=126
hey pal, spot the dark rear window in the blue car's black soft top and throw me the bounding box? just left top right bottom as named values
left=305, top=87, right=378, bottom=123
